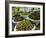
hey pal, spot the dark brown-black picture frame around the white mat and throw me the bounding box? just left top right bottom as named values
left=5, top=1, right=45, bottom=37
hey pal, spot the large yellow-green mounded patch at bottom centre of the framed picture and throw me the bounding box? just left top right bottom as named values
left=16, top=20, right=34, bottom=31
